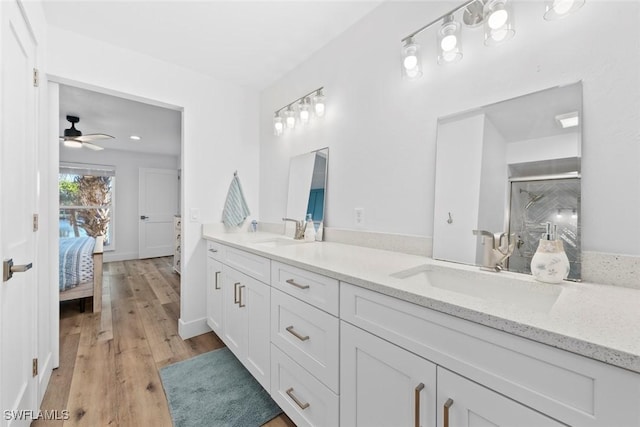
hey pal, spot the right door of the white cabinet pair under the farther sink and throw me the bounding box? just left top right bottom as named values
left=239, top=278, right=271, bottom=391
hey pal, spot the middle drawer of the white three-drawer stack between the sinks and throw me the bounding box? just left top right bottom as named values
left=271, top=288, right=340, bottom=393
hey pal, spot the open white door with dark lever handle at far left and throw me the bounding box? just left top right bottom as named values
left=0, top=1, right=37, bottom=426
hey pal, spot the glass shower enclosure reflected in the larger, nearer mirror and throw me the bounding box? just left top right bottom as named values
left=507, top=178, right=581, bottom=281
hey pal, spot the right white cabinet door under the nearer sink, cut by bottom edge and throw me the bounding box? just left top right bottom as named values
left=438, top=367, right=565, bottom=427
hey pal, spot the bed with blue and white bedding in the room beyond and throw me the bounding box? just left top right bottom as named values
left=59, top=236, right=104, bottom=313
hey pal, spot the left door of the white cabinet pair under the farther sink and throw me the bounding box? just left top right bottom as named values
left=222, top=265, right=247, bottom=363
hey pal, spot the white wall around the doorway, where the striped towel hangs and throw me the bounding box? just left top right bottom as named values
left=47, top=27, right=259, bottom=338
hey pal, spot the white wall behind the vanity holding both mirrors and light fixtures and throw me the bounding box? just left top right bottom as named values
left=260, top=0, right=640, bottom=255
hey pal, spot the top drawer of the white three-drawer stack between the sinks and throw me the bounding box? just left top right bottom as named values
left=271, top=261, right=340, bottom=316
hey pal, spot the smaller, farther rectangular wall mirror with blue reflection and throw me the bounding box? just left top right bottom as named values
left=286, top=148, right=329, bottom=229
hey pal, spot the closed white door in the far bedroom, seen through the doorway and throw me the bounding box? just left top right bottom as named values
left=138, top=168, right=180, bottom=258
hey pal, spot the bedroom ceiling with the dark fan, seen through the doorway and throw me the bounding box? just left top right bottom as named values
left=60, top=85, right=182, bottom=156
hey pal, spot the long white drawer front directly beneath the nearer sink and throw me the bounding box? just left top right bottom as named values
left=340, top=282, right=640, bottom=426
